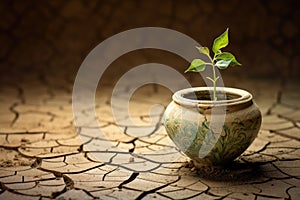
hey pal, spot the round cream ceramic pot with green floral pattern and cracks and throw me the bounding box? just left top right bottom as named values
left=164, top=87, right=262, bottom=167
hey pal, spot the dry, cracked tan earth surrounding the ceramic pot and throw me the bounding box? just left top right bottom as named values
left=0, top=71, right=300, bottom=199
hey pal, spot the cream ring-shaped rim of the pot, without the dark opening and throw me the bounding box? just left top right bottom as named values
left=172, top=87, right=253, bottom=107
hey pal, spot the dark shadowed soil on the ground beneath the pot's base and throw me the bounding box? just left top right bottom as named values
left=187, top=160, right=259, bottom=181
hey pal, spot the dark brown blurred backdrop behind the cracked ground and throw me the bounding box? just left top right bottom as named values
left=0, top=0, right=300, bottom=84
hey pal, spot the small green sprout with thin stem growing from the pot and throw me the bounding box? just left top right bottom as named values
left=185, top=28, right=241, bottom=101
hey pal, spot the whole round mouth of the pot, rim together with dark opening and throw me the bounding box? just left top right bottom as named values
left=172, top=87, right=252, bottom=107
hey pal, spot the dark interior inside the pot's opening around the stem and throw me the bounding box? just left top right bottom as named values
left=183, top=91, right=241, bottom=101
